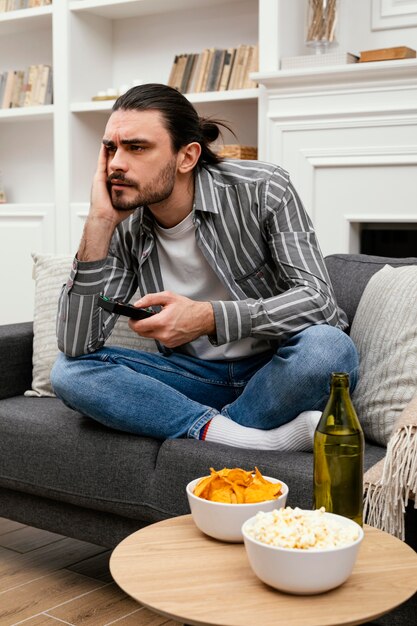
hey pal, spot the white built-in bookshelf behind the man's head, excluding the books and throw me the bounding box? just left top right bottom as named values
left=0, top=0, right=277, bottom=323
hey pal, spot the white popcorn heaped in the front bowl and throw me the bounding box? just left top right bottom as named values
left=247, top=507, right=360, bottom=550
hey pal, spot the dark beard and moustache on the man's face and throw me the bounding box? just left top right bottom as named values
left=107, top=158, right=177, bottom=211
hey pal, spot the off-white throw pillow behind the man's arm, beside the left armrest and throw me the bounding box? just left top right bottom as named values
left=25, top=253, right=156, bottom=397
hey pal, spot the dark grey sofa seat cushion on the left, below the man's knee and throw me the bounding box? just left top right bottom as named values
left=0, top=396, right=163, bottom=522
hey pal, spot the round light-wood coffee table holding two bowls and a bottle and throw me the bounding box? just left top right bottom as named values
left=110, top=515, right=417, bottom=626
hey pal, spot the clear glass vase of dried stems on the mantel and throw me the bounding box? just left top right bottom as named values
left=306, top=0, right=339, bottom=54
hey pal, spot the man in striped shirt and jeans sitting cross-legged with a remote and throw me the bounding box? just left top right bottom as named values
left=52, top=84, right=358, bottom=450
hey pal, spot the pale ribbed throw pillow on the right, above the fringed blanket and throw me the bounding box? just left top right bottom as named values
left=350, top=265, right=417, bottom=446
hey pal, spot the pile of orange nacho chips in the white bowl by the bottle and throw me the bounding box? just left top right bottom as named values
left=194, top=467, right=282, bottom=504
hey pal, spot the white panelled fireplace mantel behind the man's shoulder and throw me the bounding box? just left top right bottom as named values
left=252, top=59, right=417, bottom=254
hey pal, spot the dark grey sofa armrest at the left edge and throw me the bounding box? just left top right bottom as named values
left=0, top=322, right=33, bottom=399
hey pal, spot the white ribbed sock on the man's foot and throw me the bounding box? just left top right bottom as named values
left=204, top=411, right=321, bottom=452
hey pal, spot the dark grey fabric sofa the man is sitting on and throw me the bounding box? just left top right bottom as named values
left=0, top=254, right=417, bottom=626
